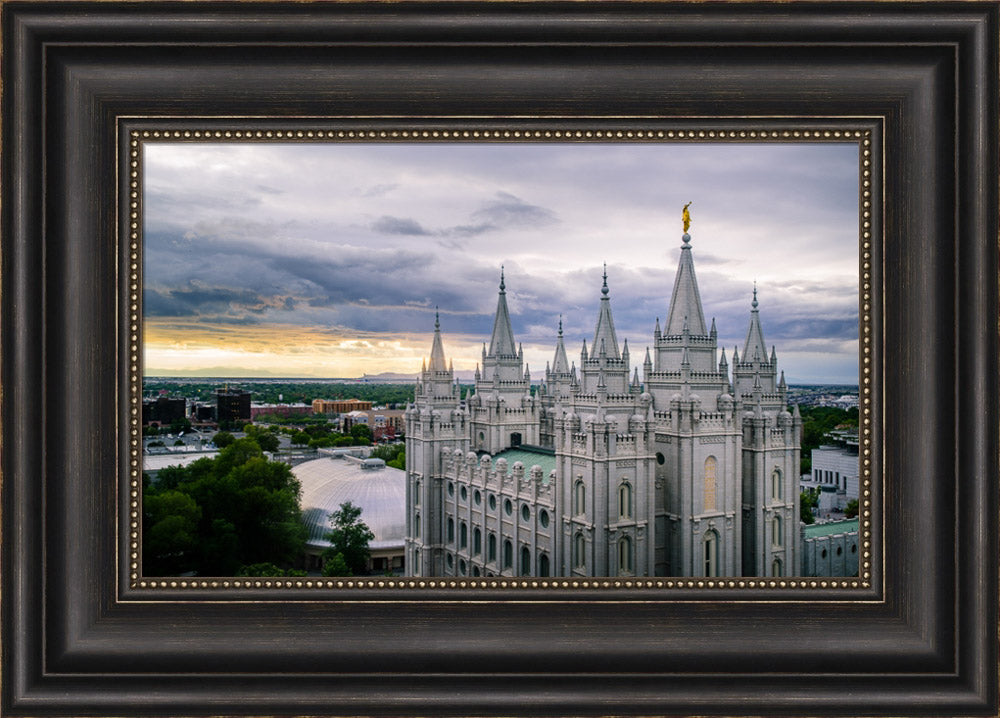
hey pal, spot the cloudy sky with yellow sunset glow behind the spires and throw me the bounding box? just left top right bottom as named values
left=143, top=143, right=858, bottom=384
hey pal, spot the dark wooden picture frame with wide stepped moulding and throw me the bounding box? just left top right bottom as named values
left=0, top=2, right=1000, bottom=716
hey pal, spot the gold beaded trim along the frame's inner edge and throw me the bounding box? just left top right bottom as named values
left=126, top=128, right=884, bottom=591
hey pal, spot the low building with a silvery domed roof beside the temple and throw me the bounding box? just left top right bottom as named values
left=292, top=458, right=406, bottom=574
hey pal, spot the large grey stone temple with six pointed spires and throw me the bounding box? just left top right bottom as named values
left=406, top=228, right=802, bottom=577
